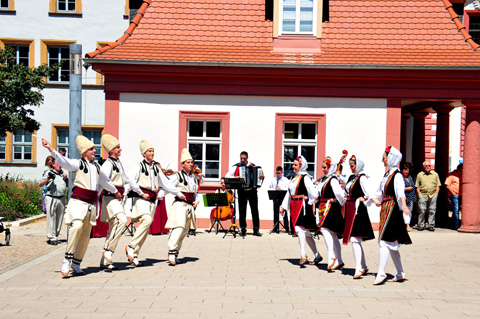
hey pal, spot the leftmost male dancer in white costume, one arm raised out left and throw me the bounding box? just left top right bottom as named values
left=52, top=135, right=117, bottom=276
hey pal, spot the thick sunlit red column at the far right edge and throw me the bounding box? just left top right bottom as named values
left=458, top=101, right=480, bottom=233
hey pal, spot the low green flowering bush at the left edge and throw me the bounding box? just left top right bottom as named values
left=0, top=173, right=43, bottom=221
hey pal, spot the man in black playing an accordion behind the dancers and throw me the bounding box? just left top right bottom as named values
left=225, top=151, right=264, bottom=236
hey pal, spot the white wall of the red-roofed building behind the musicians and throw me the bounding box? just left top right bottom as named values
left=118, top=94, right=387, bottom=228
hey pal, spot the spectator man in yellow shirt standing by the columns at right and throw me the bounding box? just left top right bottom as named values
left=415, top=162, right=441, bottom=231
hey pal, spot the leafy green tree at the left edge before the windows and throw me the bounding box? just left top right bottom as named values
left=0, top=48, right=58, bottom=136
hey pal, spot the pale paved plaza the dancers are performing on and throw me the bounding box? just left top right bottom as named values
left=0, top=225, right=480, bottom=319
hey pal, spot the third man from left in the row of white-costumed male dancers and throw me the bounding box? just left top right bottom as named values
left=125, top=140, right=185, bottom=267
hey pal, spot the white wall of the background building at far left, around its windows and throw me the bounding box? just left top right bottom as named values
left=0, top=0, right=128, bottom=179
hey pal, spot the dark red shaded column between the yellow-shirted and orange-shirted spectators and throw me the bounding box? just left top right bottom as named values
left=433, top=105, right=453, bottom=227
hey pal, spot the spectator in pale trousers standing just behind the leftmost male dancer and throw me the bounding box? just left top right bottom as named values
left=42, top=168, right=68, bottom=245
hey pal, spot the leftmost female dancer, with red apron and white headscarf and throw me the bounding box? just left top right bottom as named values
left=280, top=156, right=323, bottom=265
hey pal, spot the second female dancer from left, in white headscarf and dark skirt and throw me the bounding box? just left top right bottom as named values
left=317, top=158, right=345, bottom=270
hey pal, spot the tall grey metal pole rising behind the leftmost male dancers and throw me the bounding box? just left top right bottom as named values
left=68, top=44, right=82, bottom=198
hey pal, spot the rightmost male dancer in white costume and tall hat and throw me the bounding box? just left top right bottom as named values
left=165, top=149, right=198, bottom=265
